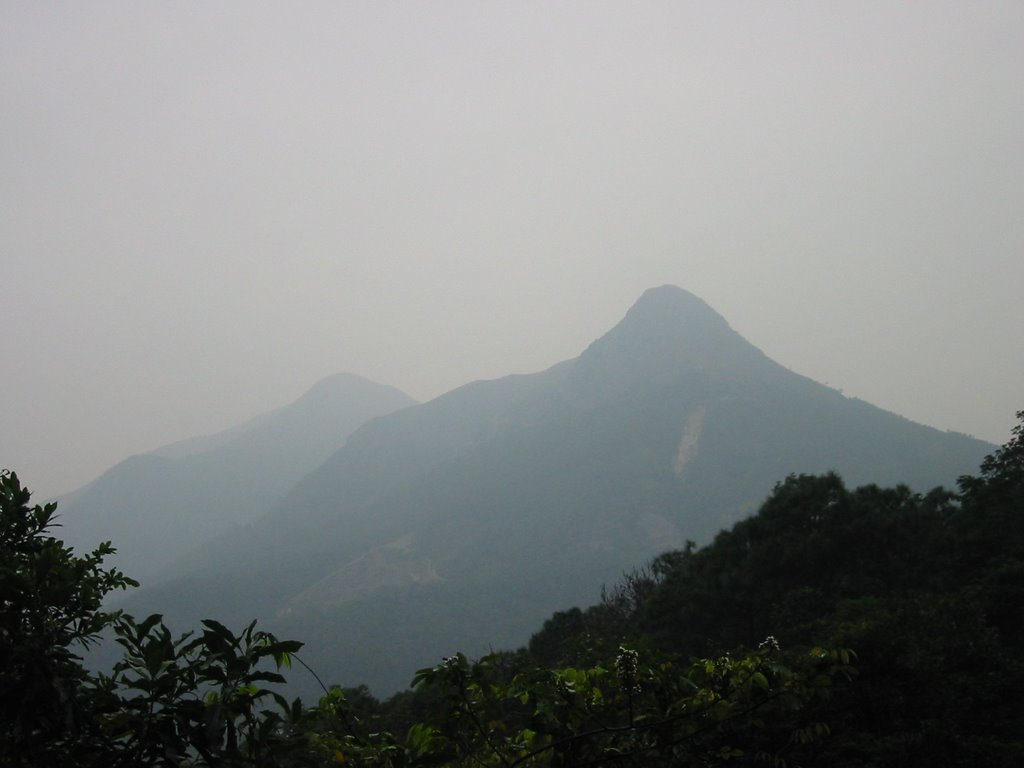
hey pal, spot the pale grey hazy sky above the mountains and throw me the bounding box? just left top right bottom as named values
left=0, top=0, right=1024, bottom=499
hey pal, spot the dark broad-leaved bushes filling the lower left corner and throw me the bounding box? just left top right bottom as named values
left=0, top=471, right=318, bottom=766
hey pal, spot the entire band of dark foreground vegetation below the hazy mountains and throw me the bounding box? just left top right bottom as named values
left=0, top=412, right=1024, bottom=768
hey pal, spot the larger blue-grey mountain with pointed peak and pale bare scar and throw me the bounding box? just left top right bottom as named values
left=128, top=286, right=992, bottom=693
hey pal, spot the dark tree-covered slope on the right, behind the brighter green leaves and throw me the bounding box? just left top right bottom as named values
left=529, top=412, right=1024, bottom=766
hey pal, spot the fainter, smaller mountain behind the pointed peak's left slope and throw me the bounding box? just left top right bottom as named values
left=59, top=374, right=416, bottom=584
